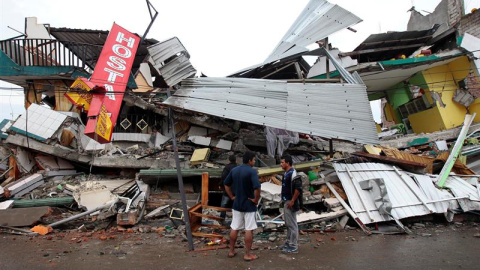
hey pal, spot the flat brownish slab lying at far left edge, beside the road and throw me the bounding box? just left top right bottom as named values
left=0, top=206, right=51, bottom=227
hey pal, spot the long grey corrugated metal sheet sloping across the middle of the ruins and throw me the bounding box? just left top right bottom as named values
left=164, top=78, right=378, bottom=143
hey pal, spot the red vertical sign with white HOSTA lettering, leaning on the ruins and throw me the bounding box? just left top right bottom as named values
left=85, top=23, right=140, bottom=143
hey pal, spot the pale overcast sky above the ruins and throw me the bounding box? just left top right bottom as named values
left=0, top=0, right=480, bottom=119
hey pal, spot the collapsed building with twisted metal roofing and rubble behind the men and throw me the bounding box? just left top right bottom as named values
left=0, top=0, right=480, bottom=249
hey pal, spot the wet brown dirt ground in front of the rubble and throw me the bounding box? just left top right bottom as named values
left=0, top=219, right=480, bottom=269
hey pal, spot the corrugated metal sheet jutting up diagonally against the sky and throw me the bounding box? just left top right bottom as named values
left=264, top=0, right=362, bottom=63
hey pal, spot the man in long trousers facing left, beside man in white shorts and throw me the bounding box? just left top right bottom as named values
left=280, top=155, right=302, bottom=253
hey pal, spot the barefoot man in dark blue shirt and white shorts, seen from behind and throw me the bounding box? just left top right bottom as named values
left=224, top=151, right=261, bottom=261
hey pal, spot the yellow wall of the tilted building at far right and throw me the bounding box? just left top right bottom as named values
left=409, top=57, right=470, bottom=133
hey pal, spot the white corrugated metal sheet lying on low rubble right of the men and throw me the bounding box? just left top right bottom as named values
left=334, top=163, right=434, bottom=224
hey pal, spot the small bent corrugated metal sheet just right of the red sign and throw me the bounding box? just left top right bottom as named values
left=148, top=37, right=197, bottom=86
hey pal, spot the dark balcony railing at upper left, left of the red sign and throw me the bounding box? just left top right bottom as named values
left=0, top=39, right=101, bottom=69
